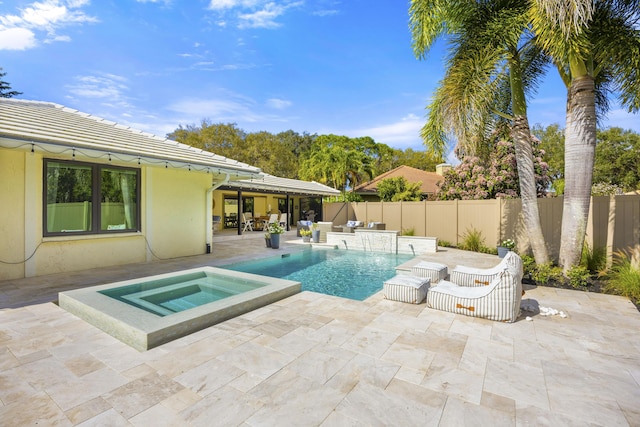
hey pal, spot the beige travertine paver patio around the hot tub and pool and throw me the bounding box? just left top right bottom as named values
left=0, top=232, right=640, bottom=426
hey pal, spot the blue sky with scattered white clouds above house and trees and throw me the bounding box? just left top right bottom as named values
left=0, top=0, right=640, bottom=157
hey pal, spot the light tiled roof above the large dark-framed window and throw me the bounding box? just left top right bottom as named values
left=0, top=98, right=260, bottom=180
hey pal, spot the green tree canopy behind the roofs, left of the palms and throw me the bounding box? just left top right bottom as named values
left=167, top=119, right=443, bottom=186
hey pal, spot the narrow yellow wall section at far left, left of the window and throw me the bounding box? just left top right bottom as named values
left=0, top=148, right=26, bottom=280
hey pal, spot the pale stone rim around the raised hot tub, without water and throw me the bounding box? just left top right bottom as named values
left=58, top=266, right=302, bottom=351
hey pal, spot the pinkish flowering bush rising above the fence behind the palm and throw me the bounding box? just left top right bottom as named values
left=437, top=138, right=551, bottom=200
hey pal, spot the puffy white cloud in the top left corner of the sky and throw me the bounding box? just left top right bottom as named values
left=0, top=0, right=97, bottom=50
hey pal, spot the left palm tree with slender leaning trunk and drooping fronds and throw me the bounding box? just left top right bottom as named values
left=410, top=0, right=549, bottom=264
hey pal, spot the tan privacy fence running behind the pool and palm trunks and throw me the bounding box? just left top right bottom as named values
left=323, top=195, right=640, bottom=258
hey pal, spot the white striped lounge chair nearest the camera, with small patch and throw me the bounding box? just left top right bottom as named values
left=427, top=266, right=522, bottom=322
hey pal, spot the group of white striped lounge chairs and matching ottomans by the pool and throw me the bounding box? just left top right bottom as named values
left=383, top=252, right=523, bottom=322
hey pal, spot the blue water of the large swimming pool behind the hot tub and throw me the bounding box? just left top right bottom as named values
left=222, top=249, right=413, bottom=301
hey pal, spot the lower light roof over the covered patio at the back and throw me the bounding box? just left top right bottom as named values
left=223, top=173, right=340, bottom=196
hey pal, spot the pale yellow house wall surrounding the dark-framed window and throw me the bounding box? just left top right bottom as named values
left=0, top=148, right=211, bottom=281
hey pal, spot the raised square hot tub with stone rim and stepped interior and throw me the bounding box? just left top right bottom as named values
left=58, top=267, right=301, bottom=351
